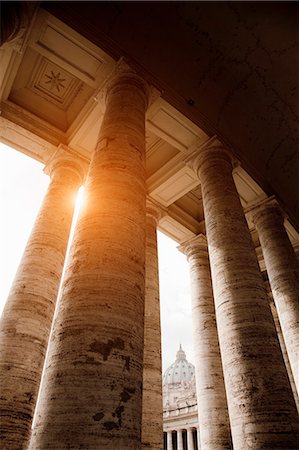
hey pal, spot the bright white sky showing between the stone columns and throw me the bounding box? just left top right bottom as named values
left=0, top=143, right=194, bottom=371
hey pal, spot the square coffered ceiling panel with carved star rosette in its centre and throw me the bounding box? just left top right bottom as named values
left=0, top=10, right=116, bottom=135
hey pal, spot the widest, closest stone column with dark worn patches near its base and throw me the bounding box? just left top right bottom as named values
left=30, top=67, right=147, bottom=450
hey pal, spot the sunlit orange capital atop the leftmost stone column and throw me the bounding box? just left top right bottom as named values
left=44, top=144, right=89, bottom=183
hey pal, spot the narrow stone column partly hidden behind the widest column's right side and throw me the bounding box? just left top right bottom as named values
left=141, top=200, right=163, bottom=450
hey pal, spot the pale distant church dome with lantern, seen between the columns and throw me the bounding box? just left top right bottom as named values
left=163, top=345, right=195, bottom=385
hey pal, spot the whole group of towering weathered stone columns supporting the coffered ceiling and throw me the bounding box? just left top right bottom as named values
left=0, top=67, right=299, bottom=450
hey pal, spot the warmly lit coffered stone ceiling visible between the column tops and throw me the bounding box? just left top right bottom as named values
left=0, top=5, right=298, bottom=245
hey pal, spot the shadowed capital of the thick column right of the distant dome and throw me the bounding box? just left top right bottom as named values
left=186, top=144, right=238, bottom=178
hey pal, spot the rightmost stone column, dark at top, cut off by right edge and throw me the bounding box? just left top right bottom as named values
left=250, top=199, right=299, bottom=393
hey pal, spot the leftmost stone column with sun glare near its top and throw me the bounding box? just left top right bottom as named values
left=0, top=150, right=84, bottom=450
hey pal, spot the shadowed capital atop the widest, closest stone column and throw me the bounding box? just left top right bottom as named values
left=104, top=58, right=151, bottom=109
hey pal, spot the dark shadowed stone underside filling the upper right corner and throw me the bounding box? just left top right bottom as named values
left=41, top=2, right=299, bottom=228
